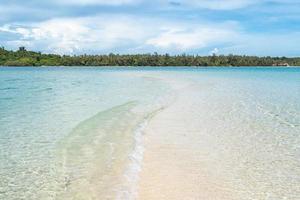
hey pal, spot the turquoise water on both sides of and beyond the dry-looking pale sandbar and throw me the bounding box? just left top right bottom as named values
left=0, top=67, right=300, bottom=200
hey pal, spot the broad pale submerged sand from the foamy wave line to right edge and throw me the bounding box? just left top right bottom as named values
left=138, top=76, right=300, bottom=200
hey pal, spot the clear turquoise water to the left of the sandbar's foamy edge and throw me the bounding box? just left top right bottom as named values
left=0, top=68, right=171, bottom=199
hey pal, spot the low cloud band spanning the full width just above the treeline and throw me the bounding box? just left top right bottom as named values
left=0, top=15, right=300, bottom=56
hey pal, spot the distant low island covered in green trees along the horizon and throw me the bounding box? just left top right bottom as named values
left=0, top=47, right=300, bottom=66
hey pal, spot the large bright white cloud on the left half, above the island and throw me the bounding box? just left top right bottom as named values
left=0, top=16, right=154, bottom=54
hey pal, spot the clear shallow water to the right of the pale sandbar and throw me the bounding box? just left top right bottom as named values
left=171, top=68, right=300, bottom=200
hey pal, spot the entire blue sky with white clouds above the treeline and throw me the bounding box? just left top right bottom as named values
left=0, top=0, right=300, bottom=57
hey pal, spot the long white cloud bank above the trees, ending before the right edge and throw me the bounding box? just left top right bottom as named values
left=0, top=15, right=236, bottom=54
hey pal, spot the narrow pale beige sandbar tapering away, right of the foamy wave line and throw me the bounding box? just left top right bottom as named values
left=138, top=82, right=236, bottom=200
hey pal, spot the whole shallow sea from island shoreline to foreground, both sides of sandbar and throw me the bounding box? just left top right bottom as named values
left=0, top=67, right=300, bottom=200
